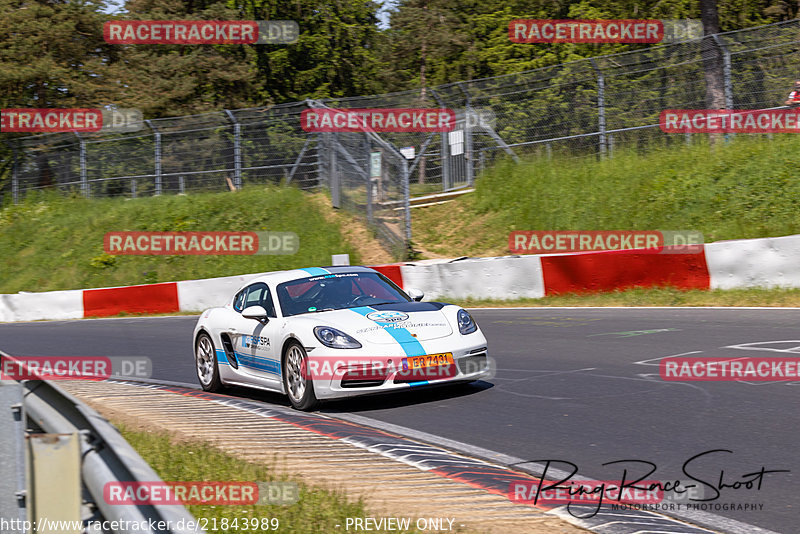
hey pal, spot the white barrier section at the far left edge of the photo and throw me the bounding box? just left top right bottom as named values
left=0, top=289, right=83, bottom=322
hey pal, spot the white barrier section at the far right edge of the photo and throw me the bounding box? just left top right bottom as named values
left=705, top=235, right=800, bottom=289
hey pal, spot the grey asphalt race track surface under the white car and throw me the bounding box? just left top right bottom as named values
left=0, top=308, right=800, bottom=533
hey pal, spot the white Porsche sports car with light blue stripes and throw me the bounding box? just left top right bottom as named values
left=193, top=267, right=490, bottom=410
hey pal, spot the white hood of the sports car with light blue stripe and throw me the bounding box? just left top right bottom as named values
left=310, top=302, right=453, bottom=344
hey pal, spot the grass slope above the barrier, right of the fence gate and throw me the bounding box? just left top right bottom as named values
left=413, top=134, right=800, bottom=257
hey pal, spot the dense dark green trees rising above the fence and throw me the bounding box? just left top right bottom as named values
left=0, top=0, right=798, bottom=113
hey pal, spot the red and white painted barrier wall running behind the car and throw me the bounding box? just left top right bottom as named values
left=0, top=235, right=800, bottom=322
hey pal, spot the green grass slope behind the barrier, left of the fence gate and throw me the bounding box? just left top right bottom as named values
left=0, top=187, right=360, bottom=293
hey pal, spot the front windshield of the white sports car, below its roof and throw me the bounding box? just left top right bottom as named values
left=277, top=272, right=411, bottom=316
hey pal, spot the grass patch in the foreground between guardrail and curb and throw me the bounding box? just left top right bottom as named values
left=118, top=425, right=424, bottom=534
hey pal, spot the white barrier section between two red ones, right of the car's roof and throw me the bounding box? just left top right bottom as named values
left=400, top=256, right=544, bottom=300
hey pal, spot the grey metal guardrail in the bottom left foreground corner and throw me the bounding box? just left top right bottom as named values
left=0, top=352, right=197, bottom=534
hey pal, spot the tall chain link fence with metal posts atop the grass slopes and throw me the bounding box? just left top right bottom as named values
left=3, top=20, right=800, bottom=254
